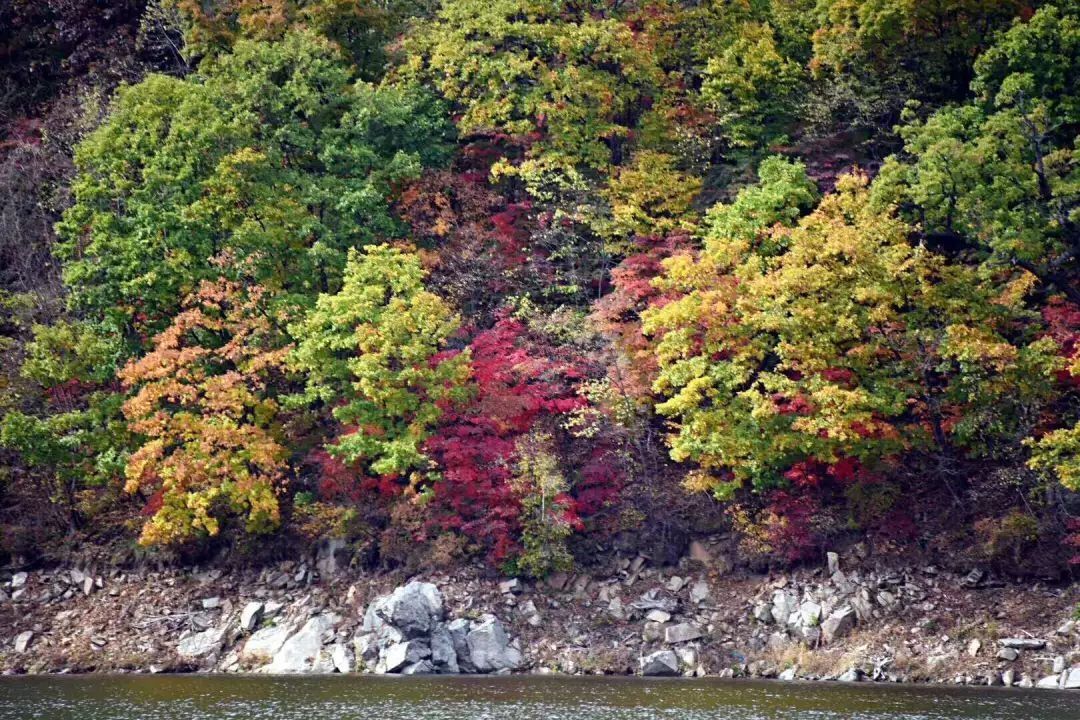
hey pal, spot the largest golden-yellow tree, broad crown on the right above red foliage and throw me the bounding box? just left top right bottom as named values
left=646, top=167, right=1056, bottom=494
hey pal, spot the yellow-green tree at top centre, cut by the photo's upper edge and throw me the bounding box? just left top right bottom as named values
left=400, top=0, right=663, bottom=168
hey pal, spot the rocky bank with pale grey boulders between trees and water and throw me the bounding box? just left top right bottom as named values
left=0, top=542, right=1080, bottom=689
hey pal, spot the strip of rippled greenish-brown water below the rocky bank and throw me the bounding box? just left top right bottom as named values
left=0, top=676, right=1080, bottom=720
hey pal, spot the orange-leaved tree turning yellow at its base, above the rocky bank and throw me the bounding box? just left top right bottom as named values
left=120, top=280, right=291, bottom=545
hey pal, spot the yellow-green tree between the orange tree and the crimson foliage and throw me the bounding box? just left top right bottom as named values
left=291, top=245, right=469, bottom=486
